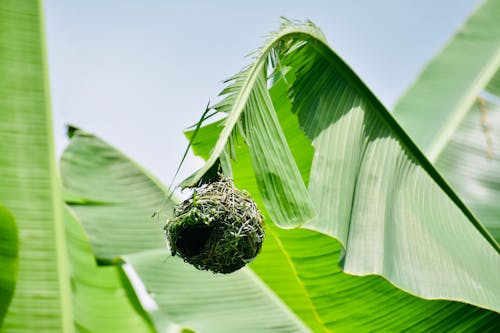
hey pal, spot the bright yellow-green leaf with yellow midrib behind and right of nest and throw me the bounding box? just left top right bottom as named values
left=188, top=110, right=500, bottom=332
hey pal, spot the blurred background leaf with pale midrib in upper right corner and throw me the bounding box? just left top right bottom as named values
left=393, top=1, right=500, bottom=242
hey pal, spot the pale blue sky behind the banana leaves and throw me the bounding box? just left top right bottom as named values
left=44, top=0, right=480, bottom=185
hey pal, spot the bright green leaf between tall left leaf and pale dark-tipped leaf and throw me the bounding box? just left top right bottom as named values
left=64, top=209, right=154, bottom=333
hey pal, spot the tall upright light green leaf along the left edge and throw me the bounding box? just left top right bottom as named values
left=0, top=0, right=72, bottom=333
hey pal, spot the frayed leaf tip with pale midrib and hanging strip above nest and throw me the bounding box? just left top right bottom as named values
left=182, top=24, right=324, bottom=228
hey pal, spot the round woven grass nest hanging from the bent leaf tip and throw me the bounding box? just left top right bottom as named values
left=165, top=176, right=265, bottom=273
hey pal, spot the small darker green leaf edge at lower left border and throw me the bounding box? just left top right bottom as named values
left=0, top=205, right=19, bottom=327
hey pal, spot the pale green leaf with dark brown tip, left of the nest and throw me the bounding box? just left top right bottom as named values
left=61, top=131, right=170, bottom=260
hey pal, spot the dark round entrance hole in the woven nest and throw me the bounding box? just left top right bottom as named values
left=176, top=225, right=212, bottom=257
